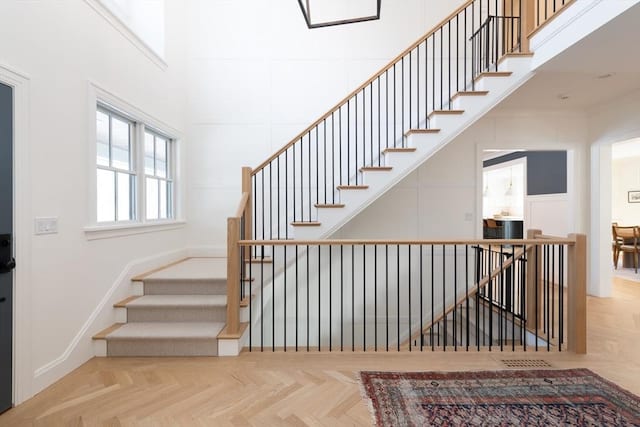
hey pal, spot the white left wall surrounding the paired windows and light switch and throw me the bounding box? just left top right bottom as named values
left=0, top=0, right=186, bottom=403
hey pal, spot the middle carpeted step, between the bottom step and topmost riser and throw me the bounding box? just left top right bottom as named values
left=124, top=295, right=227, bottom=322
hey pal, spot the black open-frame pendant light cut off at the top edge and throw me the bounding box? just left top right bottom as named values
left=298, top=0, right=382, bottom=29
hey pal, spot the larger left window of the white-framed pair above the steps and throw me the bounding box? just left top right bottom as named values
left=96, top=109, right=136, bottom=222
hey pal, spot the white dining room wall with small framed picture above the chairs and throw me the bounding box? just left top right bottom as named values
left=611, top=156, right=640, bottom=225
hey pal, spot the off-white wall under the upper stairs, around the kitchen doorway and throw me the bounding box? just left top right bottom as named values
left=337, top=111, right=589, bottom=244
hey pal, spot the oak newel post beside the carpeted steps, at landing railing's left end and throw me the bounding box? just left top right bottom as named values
left=227, top=217, right=240, bottom=334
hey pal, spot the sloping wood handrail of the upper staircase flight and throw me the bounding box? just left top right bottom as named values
left=251, top=0, right=475, bottom=175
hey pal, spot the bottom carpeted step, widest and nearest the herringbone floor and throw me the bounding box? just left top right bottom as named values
left=106, top=322, right=224, bottom=356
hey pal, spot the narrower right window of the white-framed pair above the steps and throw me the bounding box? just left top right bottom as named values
left=144, top=131, right=173, bottom=219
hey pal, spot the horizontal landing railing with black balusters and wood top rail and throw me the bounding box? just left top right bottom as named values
left=238, top=235, right=586, bottom=353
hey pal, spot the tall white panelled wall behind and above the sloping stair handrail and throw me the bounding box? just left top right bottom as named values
left=188, top=0, right=462, bottom=249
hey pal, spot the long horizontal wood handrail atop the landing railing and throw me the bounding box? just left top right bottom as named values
left=238, top=237, right=575, bottom=246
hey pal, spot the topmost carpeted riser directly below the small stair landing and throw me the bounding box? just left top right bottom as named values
left=143, top=277, right=227, bottom=295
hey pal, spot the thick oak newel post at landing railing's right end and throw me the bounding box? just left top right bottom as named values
left=567, top=234, right=587, bottom=354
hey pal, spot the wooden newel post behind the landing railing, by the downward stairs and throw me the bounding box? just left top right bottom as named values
left=526, top=230, right=544, bottom=331
